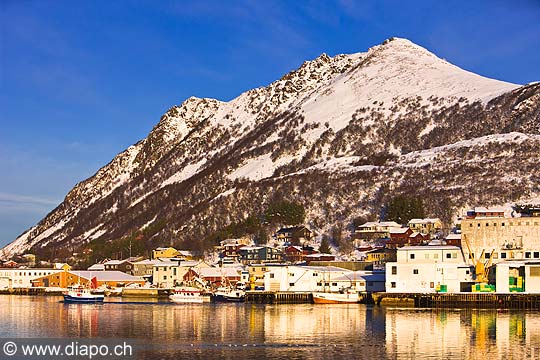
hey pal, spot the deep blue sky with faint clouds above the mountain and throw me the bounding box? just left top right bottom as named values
left=0, top=0, right=540, bottom=246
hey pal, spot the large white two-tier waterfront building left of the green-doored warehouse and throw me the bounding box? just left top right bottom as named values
left=386, top=245, right=474, bottom=293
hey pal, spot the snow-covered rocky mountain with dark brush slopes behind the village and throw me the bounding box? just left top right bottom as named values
left=3, top=38, right=540, bottom=256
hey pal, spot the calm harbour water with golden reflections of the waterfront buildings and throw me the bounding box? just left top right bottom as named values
left=0, top=295, right=540, bottom=360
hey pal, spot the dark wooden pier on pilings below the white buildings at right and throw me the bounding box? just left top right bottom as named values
left=373, top=293, right=540, bottom=309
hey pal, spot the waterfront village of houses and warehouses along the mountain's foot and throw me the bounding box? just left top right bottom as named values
left=0, top=206, right=540, bottom=302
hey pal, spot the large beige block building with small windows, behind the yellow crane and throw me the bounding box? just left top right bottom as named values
left=461, top=217, right=540, bottom=262
